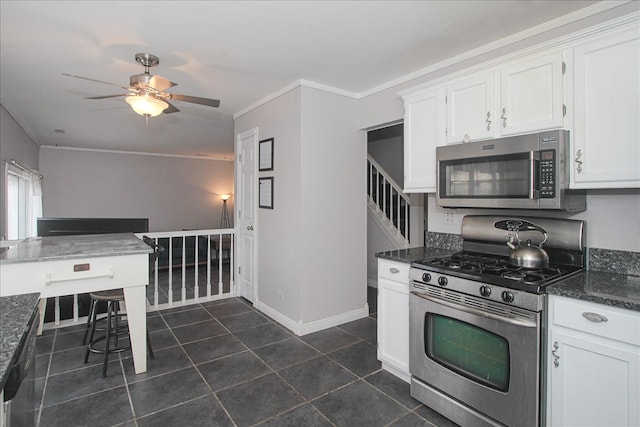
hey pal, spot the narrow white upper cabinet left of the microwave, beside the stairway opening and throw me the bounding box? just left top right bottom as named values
left=404, top=89, right=444, bottom=193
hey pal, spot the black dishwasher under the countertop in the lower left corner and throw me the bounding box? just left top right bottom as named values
left=4, top=310, right=39, bottom=427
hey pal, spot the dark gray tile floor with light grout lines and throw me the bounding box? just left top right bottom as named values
left=36, top=288, right=454, bottom=427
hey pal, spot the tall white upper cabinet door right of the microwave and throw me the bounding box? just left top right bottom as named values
left=571, top=24, right=640, bottom=188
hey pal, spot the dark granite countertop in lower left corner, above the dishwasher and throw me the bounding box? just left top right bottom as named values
left=0, top=293, right=40, bottom=390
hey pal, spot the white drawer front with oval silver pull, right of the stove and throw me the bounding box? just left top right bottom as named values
left=550, top=296, right=640, bottom=346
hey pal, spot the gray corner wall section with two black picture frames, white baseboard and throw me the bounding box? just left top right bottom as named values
left=235, top=87, right=366, bottom=325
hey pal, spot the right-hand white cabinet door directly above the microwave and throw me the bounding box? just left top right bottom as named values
left=497, top=53, right=563, bottom=135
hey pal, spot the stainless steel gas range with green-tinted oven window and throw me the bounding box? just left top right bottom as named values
left=409, top=215, right=585, bottom=426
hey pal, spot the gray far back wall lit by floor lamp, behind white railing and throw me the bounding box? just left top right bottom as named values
left=40, top=147, right=234, bottom=231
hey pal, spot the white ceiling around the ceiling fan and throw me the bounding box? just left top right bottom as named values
left=0, top=0, right=597, bottom=158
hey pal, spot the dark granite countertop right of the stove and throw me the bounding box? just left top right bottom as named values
left=546, top=271, right=640, bottom=311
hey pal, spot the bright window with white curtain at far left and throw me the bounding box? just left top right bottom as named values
left=6, top=164, right=42, bottom=240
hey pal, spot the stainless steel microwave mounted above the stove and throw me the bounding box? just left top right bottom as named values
left=436, top=130, right=586, bottom=212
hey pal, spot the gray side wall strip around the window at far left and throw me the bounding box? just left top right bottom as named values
left=0, top=105, right=39, bottom=239
